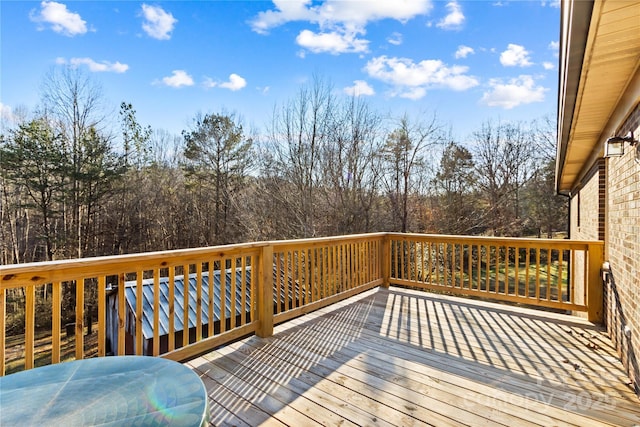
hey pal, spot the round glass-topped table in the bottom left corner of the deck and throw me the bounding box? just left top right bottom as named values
left=0, top=356, right=207, bottom=426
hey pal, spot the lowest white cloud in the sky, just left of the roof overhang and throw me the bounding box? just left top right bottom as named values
left=480, top=75, right=549, bottom=110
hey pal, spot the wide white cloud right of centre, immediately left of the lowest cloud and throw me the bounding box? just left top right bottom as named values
left=364, top=55, right=478, bottom=99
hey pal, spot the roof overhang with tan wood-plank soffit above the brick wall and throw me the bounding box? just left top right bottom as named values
left=556, top=0, right=640, bottom=194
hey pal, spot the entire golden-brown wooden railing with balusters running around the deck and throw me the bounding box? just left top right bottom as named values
left=0, top=232, right=604, bottom=376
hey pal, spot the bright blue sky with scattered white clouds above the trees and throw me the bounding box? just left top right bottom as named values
left=0, top=0, right=560, bottom=140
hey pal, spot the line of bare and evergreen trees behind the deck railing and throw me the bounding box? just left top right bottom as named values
left=0, top=68, right=567, bottom=264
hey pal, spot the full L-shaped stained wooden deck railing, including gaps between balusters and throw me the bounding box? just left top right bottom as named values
left=0, top=233, right=603, bottom=375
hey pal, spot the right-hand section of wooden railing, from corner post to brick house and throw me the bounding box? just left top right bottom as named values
left=389, top=234, right=603, bottom=321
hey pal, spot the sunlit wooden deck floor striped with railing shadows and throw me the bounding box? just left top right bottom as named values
left=188, top=287, right=640, bottom=427
